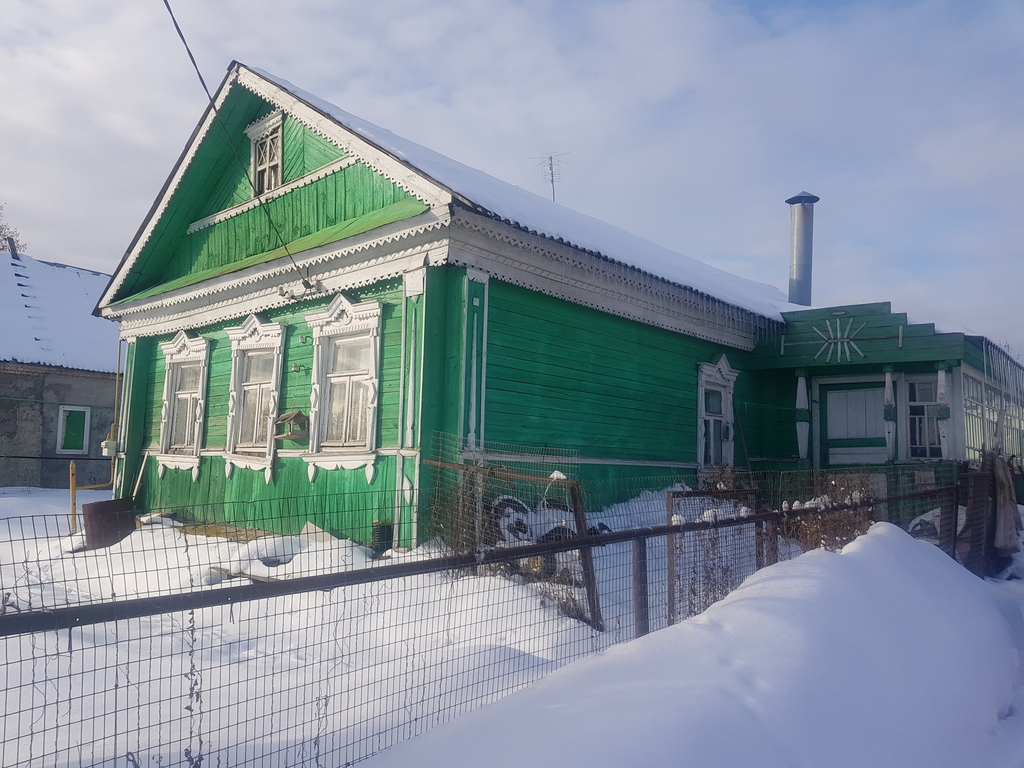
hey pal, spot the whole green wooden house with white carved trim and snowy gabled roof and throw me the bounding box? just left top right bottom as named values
left=97, top=63, right=1019, bottom=544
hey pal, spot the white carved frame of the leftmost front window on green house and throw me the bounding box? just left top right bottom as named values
left=157, top=331, right=210, bottom=480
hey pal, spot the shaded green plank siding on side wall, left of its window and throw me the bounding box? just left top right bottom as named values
left=485, top=281, right=742, bottom=462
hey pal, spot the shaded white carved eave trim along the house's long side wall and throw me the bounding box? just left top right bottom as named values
left=449, top=209, right=780, bottom=350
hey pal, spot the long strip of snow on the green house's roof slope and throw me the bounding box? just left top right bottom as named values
left=246, top=68, right=794, bottom=319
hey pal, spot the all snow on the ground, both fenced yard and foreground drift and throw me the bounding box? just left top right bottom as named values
left=0, top=490, right=1024, bottom=768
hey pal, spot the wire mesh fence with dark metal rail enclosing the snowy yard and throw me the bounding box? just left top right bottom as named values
left=0, top=462, right=958, bottom=766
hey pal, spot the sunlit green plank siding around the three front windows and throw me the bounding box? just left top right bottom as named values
left=125, top=280, right=415, bottom=541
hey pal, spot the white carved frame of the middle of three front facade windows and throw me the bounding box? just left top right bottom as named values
left=224, top=314, right=285, bottom=483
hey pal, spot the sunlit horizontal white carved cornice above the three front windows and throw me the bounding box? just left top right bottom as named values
left=102, top=208, right=449, bottom=340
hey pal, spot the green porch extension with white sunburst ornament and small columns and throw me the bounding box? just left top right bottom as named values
left=754, top=303, right=1024, bottom=469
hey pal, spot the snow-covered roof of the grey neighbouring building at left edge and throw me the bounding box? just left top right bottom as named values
left=0, top=251, right=118, bottom=373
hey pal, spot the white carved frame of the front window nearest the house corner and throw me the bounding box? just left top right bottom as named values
left=305, top=294, right=381, bottom=482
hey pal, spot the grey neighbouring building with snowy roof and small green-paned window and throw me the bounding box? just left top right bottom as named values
left=0, top=248, right=118, bottom=487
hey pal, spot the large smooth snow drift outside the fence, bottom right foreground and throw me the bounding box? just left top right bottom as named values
left=368, top=523, right=1024, bottom=768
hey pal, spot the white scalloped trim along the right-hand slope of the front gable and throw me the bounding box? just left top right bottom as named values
left=238, top=67, right=452, bottom=206
